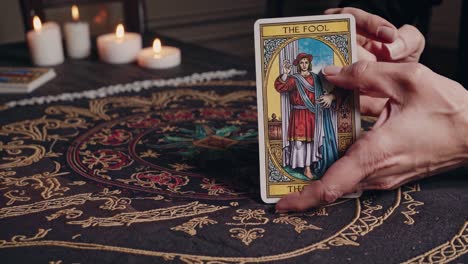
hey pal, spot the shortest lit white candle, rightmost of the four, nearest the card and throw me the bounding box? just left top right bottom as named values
left=137, top=39, right=181, bottom=69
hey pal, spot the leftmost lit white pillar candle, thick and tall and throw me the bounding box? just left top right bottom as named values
left=26, top=16, right=64, bottom=66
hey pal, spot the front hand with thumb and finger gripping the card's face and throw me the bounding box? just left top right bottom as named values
left=276, top=61, right=468, bottom=212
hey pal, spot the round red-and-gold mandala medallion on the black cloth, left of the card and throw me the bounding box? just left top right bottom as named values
left=67, top=89, right=257, bottom=199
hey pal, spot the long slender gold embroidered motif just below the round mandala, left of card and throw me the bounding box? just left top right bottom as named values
left=68, top=201, right=229, bottom=228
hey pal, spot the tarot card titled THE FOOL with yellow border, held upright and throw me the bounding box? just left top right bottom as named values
left=254, top=15, right=361, bottom=203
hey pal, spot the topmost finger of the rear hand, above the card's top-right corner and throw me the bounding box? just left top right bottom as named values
left=325, top=7, right=398, bottom=43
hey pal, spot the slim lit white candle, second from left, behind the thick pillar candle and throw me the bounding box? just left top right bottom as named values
left=63, top=5, right=91, bottom=59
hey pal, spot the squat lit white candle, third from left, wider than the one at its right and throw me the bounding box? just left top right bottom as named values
left=97, top=24, right=141, bottom=64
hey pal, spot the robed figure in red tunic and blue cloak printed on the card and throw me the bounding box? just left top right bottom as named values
left=275, top=53, right=338, bottom=179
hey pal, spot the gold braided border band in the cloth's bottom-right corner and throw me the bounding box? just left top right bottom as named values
left=403, top=221, right=468, bottom=264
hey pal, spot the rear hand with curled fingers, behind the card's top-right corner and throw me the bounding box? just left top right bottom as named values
left=325, top=7, right=425, bottom=116
